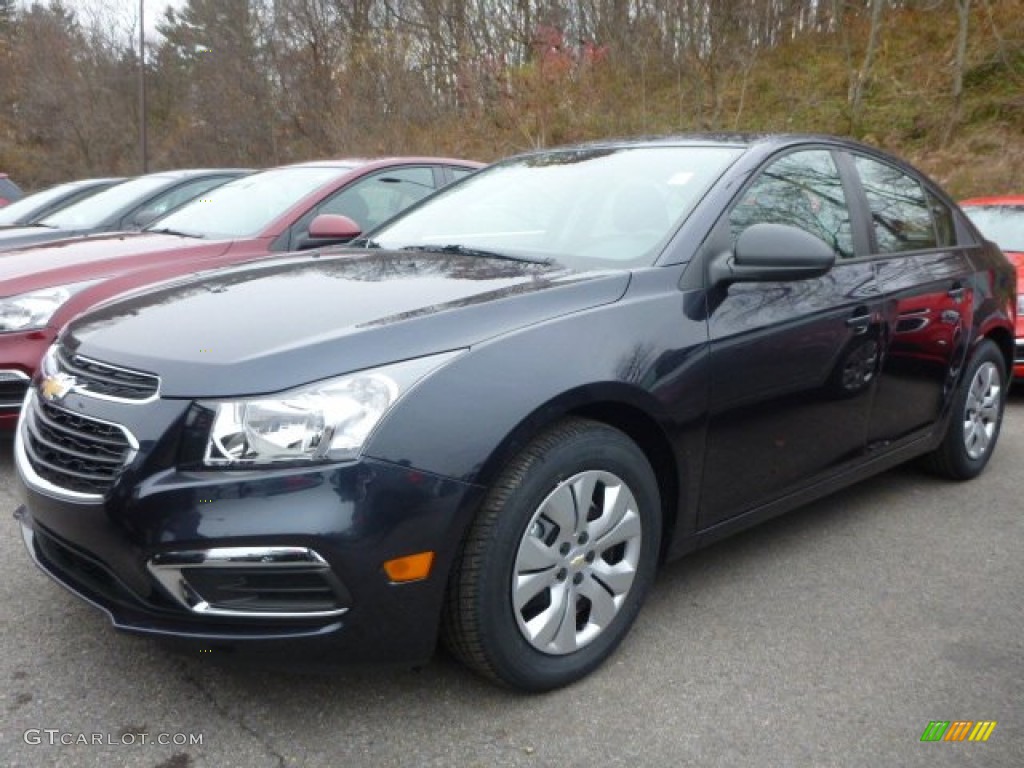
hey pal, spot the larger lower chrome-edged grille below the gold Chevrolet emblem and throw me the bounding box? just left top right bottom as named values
left=23, top=397, right=135, bottom=495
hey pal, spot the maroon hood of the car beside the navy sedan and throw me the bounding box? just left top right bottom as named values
left=0, top=232, right=230, bottom=296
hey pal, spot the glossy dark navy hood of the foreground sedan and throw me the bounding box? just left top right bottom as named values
left=65, top=251, right=630, bottom=397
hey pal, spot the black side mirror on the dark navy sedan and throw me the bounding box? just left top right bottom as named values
left=708, top=224, right=836, bottom=286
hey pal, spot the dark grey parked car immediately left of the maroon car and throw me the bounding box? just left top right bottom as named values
left=0, top=168, right=245, bottom=250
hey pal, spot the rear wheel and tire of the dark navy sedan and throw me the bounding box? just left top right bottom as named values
left=927, top=339, right=1008, bottom=480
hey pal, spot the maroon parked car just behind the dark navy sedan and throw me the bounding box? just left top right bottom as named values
left=0, top=158, right=481, bottom=430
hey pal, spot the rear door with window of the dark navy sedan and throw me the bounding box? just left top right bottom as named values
left=852, top=155, right=975, bottom=450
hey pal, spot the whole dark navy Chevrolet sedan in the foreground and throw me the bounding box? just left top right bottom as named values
left=14, top=136, right=1016, bottom=691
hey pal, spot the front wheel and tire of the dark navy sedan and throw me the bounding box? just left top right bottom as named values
left=442, top=419, right=662, bottom=692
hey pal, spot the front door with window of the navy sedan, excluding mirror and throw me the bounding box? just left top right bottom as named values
left=698, top=148, right=881, bottom=529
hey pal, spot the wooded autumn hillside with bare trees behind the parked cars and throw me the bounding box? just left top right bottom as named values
left=0, top=0, right=1024, bottom=198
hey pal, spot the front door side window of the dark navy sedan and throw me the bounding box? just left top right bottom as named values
left=729, top=150, right=853, bottom=258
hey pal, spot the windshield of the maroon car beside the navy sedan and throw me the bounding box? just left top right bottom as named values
left=146, top=165, right=351, bottom=240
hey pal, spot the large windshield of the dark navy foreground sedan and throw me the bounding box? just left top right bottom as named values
left=370, top=145, right=742, bottom=270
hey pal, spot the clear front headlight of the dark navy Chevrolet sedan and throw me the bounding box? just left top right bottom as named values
left=200, top=351, right=460, bottom=467
